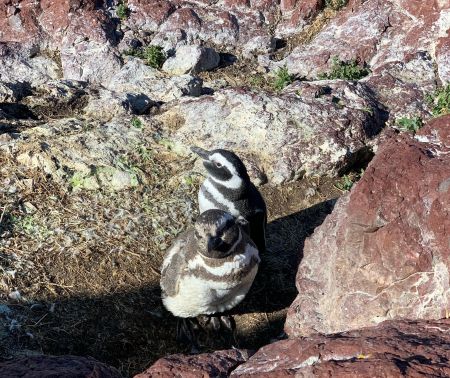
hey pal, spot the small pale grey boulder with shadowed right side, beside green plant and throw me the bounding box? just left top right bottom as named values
left=162, top=46, right=220, bottom=75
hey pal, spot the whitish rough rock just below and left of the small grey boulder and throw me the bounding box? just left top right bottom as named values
left=107, top=58, right=202, bottom=102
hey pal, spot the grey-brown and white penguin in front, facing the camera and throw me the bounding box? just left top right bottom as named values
left=160, top=209, right=260, bottom=349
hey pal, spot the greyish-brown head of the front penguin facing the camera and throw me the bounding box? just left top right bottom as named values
left=194, top=209, right=242, bottom=259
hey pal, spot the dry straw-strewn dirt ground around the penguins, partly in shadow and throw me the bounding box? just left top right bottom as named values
left=0, top=135, right=342, bottom=376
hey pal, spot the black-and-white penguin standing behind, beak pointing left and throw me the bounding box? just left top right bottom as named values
left=191, top=147, right=267, bottom=254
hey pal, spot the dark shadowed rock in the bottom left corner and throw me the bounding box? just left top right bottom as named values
left=0, top=356, right=122, bottom=378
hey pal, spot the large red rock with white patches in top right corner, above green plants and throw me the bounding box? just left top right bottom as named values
left=286, top=0, right=450, bottom=83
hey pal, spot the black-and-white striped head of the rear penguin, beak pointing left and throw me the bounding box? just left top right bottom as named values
left=191, top=147, right=250, bottom=188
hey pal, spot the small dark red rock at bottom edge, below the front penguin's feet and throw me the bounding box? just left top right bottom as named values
left=134, top=349, right=253, bottom=378
